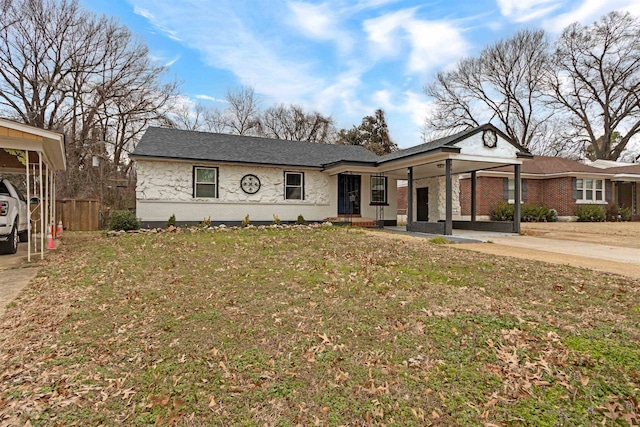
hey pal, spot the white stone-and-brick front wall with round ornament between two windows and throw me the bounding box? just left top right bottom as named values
left=136, top=160, right=336, bottom=222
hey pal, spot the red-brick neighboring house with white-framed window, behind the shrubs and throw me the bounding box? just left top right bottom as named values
left=460, top=156, right=640, bottom=220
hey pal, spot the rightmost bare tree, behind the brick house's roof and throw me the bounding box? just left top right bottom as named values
left=550, top=12, right=640, bottom=160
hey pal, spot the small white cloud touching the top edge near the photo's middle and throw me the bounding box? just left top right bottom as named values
left=289, top=2, right=353, bottom=54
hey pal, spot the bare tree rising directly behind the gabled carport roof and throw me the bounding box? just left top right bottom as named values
left=425, top=30, right=552, bottom=147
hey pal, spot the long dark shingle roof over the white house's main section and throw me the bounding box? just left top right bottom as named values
left=132, top=127, right=379, bottom=167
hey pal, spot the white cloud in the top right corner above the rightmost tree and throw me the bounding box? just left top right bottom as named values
left=543, top=0, right=640, bottom=33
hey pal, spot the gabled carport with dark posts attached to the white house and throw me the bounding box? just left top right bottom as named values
left=378, top=123, right=533, bottom=235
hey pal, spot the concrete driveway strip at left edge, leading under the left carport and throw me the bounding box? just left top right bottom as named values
left=0, top=243, right=40, bottom=317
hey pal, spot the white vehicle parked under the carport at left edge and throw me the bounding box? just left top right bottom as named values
left=0, top=178, right=29, bottom=254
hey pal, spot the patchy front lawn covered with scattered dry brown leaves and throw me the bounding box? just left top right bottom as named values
left=0, top=227, right=640, bottom=426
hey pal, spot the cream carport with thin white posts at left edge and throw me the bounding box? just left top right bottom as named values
left=0, top=119, right=67, bottom=261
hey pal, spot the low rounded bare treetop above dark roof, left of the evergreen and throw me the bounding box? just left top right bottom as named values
left=259, top=104, right=335, bottom=143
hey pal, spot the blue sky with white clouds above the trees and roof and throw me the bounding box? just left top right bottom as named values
left=80, top=0, right=640, bottom=148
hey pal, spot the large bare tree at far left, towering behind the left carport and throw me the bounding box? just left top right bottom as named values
left=0, top=0, right=176, bottom=204
